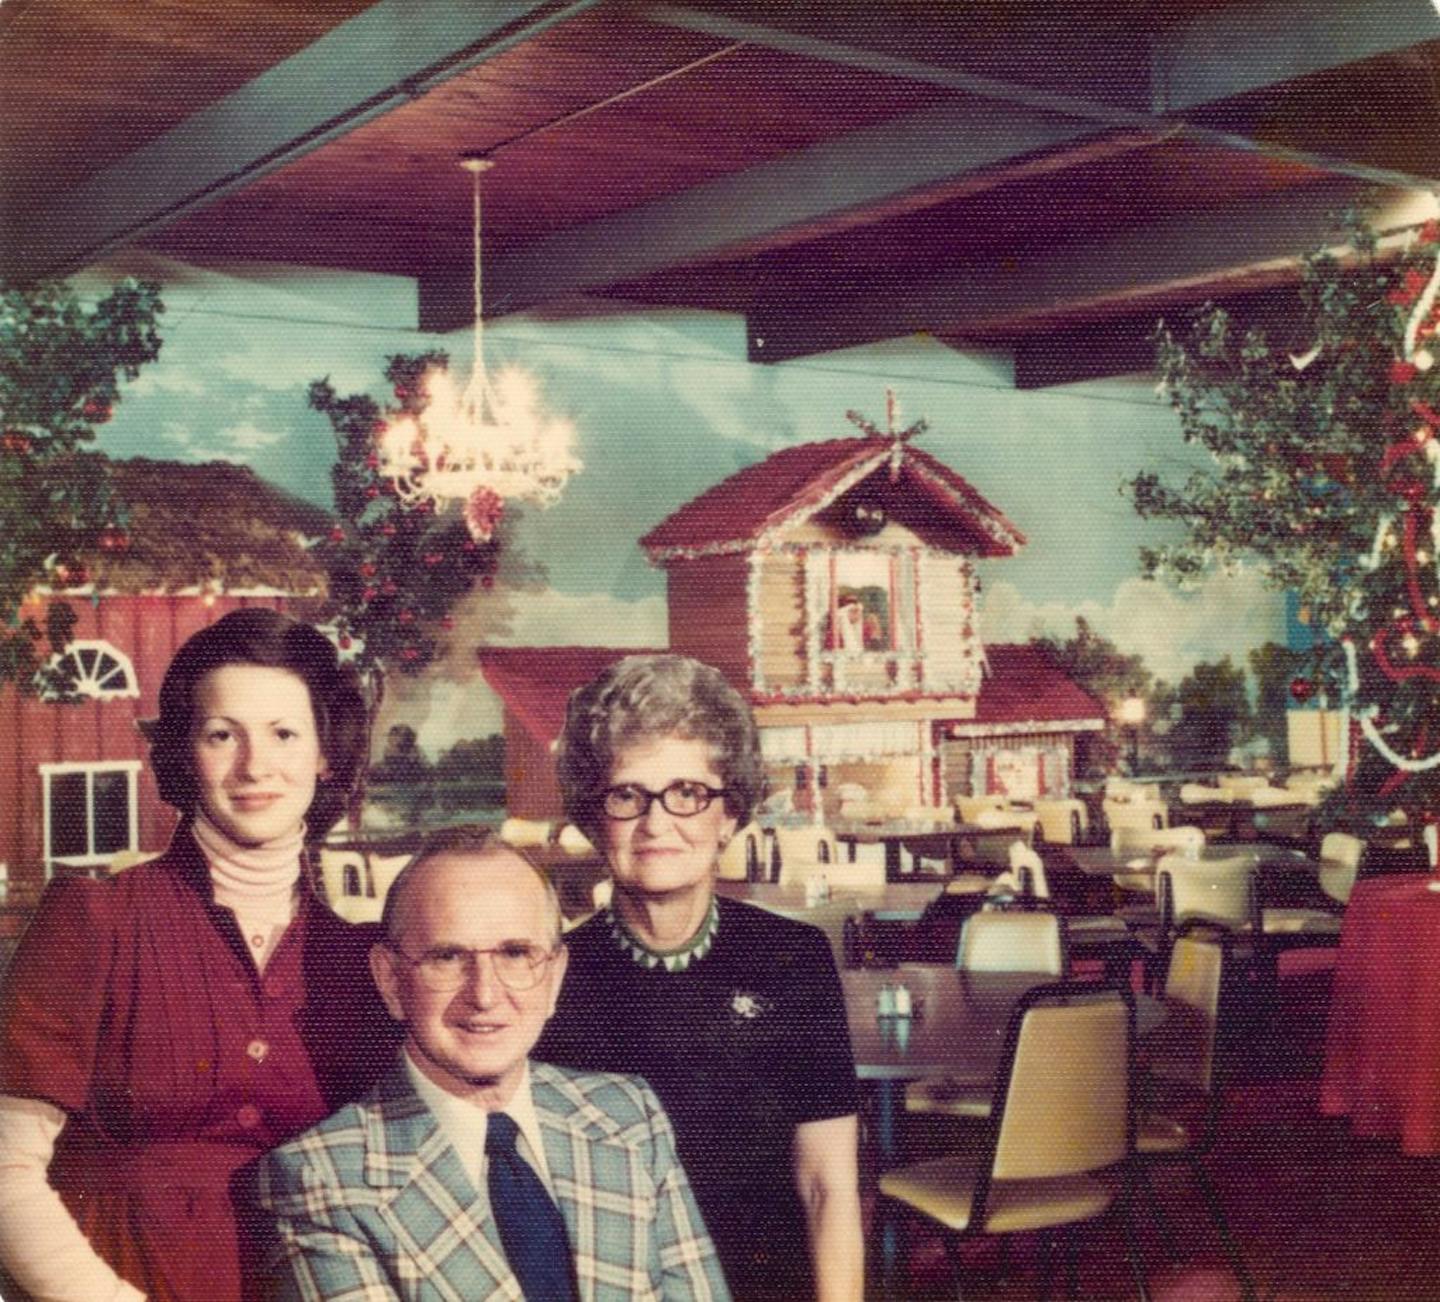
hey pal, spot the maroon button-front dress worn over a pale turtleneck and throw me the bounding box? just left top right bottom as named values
left=0, top=830, right=396, bottom=1302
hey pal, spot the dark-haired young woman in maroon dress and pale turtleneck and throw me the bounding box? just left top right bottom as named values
left=0, top=609, right=393, bottom=1302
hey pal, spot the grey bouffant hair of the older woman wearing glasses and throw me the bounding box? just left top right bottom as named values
left=557, top=655, right=765, bottom=841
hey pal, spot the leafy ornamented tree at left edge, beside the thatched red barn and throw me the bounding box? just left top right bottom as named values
left=0, top=279, right=163, bottom=691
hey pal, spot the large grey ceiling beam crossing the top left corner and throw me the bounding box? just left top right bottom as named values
left=0, top=0, right=599, bottom=282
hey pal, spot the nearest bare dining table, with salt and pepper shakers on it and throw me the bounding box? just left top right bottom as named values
left=840, top=964, right=1165, bottom=1279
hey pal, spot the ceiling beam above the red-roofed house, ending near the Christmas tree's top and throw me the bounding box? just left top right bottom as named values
left=749, top=184, right=1436, bottom=362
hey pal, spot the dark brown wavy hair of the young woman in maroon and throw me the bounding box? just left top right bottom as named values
left=145, top=606, right=366, bottom=840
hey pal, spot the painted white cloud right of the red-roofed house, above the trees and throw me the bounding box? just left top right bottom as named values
left=981, top=570, right=1284, bottom=683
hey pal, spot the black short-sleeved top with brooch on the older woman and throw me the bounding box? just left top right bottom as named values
left=534, top=899, right=857, bottom=1299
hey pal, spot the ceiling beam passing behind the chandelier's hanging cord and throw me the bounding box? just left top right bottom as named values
left=420, top=101, right=1105, bottom=331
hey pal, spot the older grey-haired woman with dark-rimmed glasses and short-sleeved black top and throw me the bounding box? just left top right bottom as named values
left=536, top=655, right=863, bottom=1299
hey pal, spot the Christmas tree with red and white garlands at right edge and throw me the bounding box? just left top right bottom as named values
left=1130, top=203, right=1440, bottom=822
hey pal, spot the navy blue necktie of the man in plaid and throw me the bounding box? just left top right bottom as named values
left=485, top=1112, right=579, bottom=1302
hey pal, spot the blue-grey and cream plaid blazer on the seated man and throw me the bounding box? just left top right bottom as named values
left=256, top=1060, right=730, bottom=1302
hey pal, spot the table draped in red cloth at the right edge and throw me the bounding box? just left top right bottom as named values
left=1319, top=874, right=1440, bottom=1157
